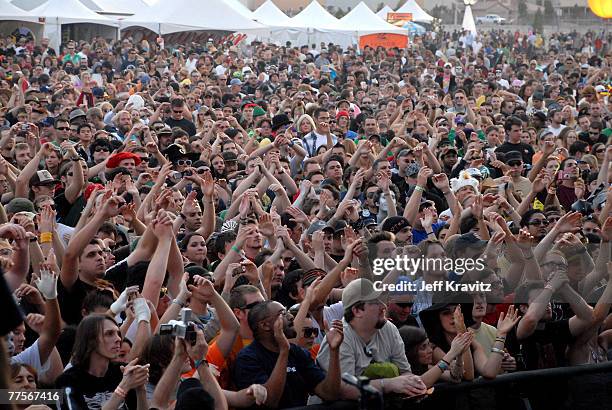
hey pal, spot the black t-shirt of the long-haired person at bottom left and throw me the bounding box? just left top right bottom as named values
left=55, top=363, right=136, bottom=410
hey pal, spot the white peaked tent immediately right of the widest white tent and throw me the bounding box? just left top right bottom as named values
left=253, top=0, right=308, bottom=44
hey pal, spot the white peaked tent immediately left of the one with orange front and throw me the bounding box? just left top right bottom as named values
left=286, top=0, right=357, bottom=47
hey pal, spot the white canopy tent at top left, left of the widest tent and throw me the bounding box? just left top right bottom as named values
left=30, top=0, right=117, bottom=51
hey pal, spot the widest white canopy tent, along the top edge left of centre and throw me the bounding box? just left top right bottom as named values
left=121, top=0, right=267, bottom=34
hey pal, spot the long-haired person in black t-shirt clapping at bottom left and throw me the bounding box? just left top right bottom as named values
left=56, top=312, right=151, bottom=409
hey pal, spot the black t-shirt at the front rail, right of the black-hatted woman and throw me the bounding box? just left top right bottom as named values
left=507, top=319, right=573, bottom=370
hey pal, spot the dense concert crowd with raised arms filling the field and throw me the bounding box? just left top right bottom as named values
left=0, top=24, right=612, bottom=410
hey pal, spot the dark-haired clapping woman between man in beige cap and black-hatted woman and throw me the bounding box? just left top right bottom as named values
left=399, top=326, right=473, bottom=388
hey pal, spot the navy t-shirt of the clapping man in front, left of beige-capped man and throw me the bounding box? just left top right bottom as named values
left=234, top=341, right=326, bottom=408
